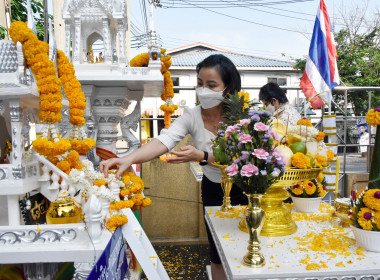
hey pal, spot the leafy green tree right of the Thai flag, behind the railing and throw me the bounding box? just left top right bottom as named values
left=293, top=3, right=380, bottom=115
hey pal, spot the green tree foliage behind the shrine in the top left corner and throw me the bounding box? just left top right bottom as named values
left=0, top=0, right=49, bottom=41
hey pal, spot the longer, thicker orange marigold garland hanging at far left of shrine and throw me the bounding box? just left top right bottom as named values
left=9, top=21, right=70, bottom=156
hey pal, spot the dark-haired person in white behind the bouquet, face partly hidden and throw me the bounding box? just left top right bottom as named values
left=259, top=83, right=301, bottom=125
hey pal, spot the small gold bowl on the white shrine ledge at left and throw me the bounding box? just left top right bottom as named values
left=46, top=200, right=82, bottom=224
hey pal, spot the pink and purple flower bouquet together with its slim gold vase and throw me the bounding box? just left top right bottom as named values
left=212, top=92, right=286, bottom=267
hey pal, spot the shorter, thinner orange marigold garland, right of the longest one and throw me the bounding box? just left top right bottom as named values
left=57, top=50, right=96, bottom=155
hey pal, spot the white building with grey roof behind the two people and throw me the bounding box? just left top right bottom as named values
left=142, top=42, right=303, bottom=137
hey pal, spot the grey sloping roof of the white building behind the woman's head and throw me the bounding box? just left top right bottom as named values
left=170, top=49, right=292, bottom=67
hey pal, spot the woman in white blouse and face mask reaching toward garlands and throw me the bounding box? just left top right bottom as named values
left=99, top=54, right=247, bottom=279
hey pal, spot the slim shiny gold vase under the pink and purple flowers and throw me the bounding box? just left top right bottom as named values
left=243, top=193, right=265, bottom=268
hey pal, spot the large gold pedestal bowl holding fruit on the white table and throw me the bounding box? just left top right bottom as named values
left=239, top=168, right=322, bottom=236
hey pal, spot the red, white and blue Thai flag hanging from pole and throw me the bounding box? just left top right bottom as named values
left=300, top=0, right=339, bottom=109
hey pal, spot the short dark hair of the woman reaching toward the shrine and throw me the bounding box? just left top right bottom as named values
left=196, top=54, right=241, bottom=94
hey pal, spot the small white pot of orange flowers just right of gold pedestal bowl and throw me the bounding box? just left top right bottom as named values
left=288, top=179, right=326, bottom=213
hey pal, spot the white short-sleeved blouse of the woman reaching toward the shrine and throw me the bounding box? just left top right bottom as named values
left=156, top=105, right=222, bottom=183
